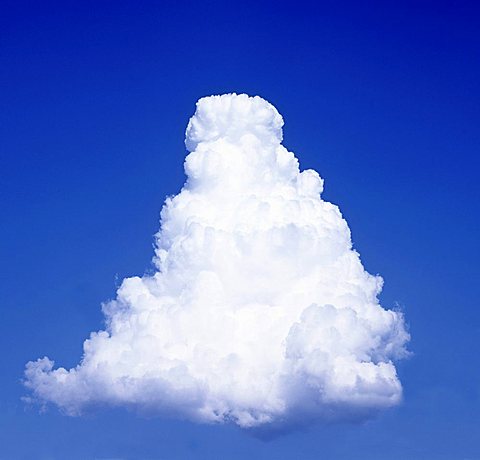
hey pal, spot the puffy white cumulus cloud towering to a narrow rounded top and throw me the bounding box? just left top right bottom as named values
left=25, top=94, right=409, bottom=427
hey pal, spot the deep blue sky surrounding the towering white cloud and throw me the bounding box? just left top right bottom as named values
left=0, top=2, right=480, bottom=459
